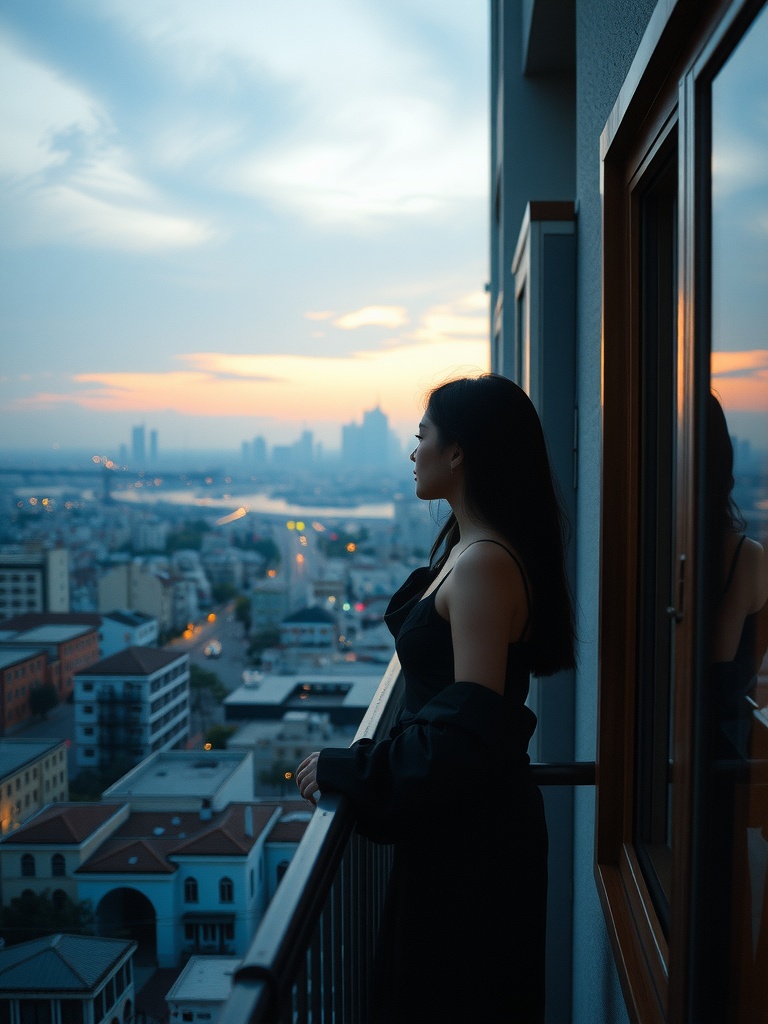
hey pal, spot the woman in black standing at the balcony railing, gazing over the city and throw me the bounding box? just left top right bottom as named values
left=297, top=374, right=573, bottom=1024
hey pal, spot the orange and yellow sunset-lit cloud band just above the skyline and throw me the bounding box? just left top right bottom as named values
left=9, top=295, right=488, bottom=434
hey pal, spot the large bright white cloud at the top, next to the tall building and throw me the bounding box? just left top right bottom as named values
left=83, top=0, right=488, bottom=227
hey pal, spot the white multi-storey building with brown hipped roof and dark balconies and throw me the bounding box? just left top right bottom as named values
left=75, top=647, right=189, bottom=768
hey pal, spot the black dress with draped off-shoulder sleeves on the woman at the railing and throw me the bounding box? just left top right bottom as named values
left=317, top=542, right=547, bottom=1024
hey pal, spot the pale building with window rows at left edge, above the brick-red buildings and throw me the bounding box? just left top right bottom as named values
left=0, top=548, right=70, bottom=621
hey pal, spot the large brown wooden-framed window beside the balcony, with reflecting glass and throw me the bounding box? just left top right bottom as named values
left=596, top=0, right=768, bottom=1024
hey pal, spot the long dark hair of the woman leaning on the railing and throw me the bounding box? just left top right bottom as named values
left=426, top=374, right=574, bottom=676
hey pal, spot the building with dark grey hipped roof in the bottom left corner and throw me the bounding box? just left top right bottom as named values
left=0, top=934, right=136, bottom=1024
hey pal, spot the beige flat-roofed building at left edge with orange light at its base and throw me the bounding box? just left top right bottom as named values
left=0, top=737, right=70, bottom=836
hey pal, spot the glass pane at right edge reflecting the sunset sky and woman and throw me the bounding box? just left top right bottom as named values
left=702, top=8, right=768, bottom=1024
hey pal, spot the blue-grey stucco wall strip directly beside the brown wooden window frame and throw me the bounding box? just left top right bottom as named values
left=572, top=0, right=655, bottom=1024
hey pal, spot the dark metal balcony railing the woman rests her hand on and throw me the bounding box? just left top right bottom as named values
left=218, top=656, right=595, bottom=1024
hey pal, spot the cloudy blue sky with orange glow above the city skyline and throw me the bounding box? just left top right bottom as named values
left=0, top=0, right=489, bottom=455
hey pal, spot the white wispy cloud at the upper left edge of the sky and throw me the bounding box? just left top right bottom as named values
left=0, top=37, right=214, bottom=251
